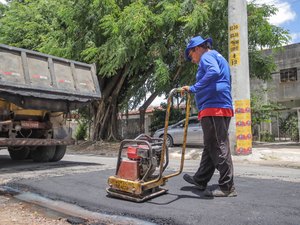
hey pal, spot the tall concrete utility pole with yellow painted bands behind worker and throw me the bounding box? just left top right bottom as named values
left=228, top=0, right=252, bottom=155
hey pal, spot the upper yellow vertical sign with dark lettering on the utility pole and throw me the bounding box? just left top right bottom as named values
left=229, top=24, right=241, bottom=66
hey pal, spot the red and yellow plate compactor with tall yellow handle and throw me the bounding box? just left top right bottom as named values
left=106, top=89, right=191, bottom=202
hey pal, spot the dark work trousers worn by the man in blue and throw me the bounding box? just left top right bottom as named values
left=194, top=116, right=234, bottom=191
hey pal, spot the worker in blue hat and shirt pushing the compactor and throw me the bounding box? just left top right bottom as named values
left=182, top=36, right=237, bottom=197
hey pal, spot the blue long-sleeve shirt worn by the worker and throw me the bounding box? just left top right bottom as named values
left=190, top=50, right=233, bottom=111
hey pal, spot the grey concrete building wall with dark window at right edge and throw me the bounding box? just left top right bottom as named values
left=250, top=43, right=300, bottom=141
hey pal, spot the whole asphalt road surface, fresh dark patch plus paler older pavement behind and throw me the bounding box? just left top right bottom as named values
left=0, top=153, right=300, bottom=225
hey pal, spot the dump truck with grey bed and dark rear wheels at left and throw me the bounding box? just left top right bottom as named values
left=0, top=44, right=101, bottom=162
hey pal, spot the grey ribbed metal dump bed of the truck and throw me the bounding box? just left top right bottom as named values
left=0, top=44, right=101, bottom=112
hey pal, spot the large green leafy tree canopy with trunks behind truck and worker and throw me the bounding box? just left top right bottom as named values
left=0, top=0, right=288, bottom=140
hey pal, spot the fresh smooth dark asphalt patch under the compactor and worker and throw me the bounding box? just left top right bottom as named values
left=8, top=170, right=300, bottom=225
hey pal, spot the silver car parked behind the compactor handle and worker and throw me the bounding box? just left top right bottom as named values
left=153, top=116, right=203, bottom=147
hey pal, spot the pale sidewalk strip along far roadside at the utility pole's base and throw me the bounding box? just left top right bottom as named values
left=170, top=142, right=300, bottom=169
